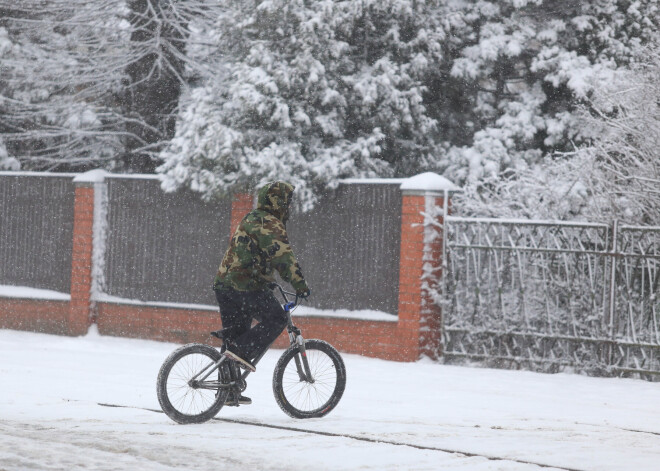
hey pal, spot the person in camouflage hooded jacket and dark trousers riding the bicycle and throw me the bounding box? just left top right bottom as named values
left=213, top=181, right=310, bottom=404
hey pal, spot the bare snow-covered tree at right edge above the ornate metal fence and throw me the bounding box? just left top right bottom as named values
left=582, top=48, right=660, bottom=225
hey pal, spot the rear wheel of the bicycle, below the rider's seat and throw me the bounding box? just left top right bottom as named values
left=156, top=343, right=229, bottom=424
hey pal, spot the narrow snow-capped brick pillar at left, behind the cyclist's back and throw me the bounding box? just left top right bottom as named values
left=67, top=170, right=106, bottom=335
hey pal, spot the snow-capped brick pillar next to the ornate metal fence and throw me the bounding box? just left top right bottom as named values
left=398, top=173, right=458, bottom=361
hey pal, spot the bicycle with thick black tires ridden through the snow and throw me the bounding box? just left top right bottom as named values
left=156, top=283, right=346, bottom=424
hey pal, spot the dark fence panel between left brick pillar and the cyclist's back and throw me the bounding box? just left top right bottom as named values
left=105, top=177, right=231, bottom=305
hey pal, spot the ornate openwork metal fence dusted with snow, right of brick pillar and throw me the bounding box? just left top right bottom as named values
left=443, top=217, right=660, bottom=377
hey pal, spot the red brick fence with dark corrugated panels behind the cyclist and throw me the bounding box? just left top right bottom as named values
left=0, top=170, right=446, bottom=361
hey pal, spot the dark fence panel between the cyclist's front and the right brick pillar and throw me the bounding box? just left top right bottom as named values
left=287, top=183, right=401, bottom=314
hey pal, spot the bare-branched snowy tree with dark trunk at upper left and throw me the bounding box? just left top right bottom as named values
left=0, top=0, right=223, bottom=171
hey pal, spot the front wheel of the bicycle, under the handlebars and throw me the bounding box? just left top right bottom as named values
left=273, top=339, right=346, bottom=419
